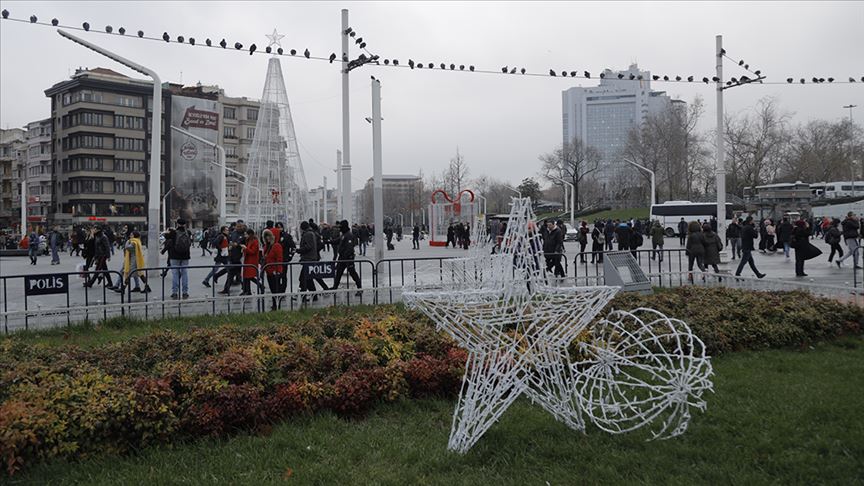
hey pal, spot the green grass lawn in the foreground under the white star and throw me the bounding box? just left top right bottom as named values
left=7, top=338, right=864, bottom=486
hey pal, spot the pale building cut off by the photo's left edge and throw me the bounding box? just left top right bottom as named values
left=0, top=128, right=27, bottom=231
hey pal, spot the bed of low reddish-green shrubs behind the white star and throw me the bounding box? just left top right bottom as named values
left=0, top=288, right=864, bottom=474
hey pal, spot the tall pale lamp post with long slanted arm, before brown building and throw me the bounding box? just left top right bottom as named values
left=57, top=29, right=162, bottom=268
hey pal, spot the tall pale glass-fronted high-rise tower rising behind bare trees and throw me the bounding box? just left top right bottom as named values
left=562, top=64, right=683, bottom=193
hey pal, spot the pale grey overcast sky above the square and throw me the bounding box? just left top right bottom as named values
left=0, top=1, right=864, bottom=188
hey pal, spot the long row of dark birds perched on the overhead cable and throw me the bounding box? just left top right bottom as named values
left=2, top=9, right=864, bottom=85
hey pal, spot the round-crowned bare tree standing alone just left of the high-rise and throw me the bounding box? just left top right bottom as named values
left=540, top=137, right=602, bottom=210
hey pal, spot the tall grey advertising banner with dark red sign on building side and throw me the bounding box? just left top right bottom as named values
left=168, top=96, right=225, bottom=228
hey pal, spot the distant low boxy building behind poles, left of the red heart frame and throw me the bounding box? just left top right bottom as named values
left=363, top=174, right=425, bottom=225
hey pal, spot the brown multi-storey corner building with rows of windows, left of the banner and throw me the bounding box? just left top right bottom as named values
left=45, top=68, right=170, bottom=233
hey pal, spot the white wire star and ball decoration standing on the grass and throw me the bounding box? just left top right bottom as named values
left=403, top=198, right=711, bottom=453
